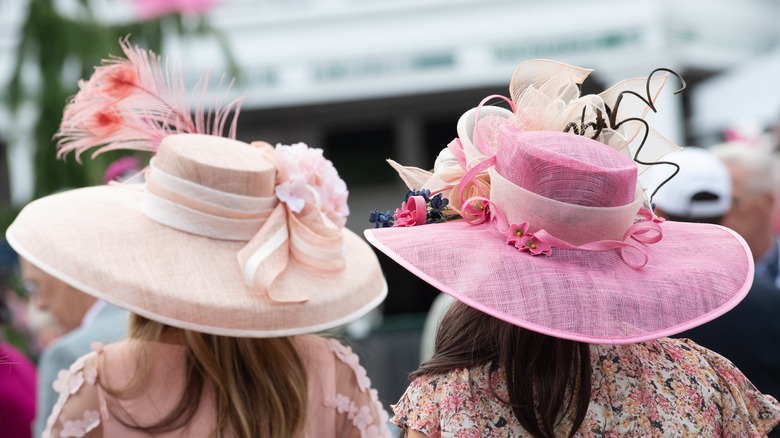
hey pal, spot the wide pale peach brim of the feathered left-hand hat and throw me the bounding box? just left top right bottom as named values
left=6, top=185, right=387, bottom=337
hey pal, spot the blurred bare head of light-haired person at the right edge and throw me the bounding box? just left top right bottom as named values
left=711, top=142, right=780, bottom=287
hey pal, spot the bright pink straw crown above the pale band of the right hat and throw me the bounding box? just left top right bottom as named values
left=495, top=127, right=637, bottom=207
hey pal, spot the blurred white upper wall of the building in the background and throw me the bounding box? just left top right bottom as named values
left=0, top=0, right=780, bottom=202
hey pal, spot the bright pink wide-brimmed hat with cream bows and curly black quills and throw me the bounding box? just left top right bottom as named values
left=365, top=61, right=754, bottom=344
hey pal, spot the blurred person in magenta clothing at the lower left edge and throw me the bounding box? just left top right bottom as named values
left=0, top=242, right=35, bottom=438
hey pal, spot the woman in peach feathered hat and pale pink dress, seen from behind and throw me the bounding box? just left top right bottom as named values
left=7, top=41, right=389, bottom=438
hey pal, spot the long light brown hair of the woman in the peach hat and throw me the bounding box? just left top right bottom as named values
left=101, top=314, right=308, bottom=438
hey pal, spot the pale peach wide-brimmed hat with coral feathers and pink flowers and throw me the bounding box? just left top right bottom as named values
left=6, top=38, right=387, bottom=337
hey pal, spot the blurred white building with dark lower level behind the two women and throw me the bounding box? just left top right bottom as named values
left=0, top=0, right=780, bottom=408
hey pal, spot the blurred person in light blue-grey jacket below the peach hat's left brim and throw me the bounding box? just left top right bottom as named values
left=20, top=258, right=128, bottom=436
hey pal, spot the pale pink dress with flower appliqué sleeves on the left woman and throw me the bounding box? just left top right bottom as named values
left=43, top=335, right=390, bottom=438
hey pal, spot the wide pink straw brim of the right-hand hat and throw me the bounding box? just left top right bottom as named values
left=365, top=220, right=754, bottom=344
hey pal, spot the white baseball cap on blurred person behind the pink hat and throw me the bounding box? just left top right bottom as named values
left=653, top=147, right=731, bottom=219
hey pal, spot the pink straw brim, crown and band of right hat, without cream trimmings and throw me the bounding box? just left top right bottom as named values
left=365, top=122, right=754, bottom=344
